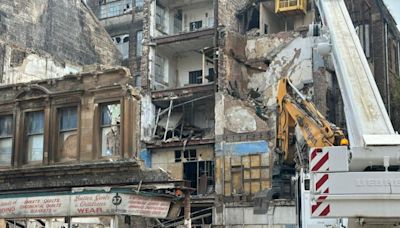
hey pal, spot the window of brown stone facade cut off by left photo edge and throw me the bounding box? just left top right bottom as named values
left=0, top=115, right=13, bottom=165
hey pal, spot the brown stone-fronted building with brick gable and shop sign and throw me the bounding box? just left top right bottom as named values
left=0, top=0, right=190, bottom=227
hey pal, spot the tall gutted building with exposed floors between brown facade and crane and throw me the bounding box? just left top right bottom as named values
left=140, top=0, right=398, bottom=227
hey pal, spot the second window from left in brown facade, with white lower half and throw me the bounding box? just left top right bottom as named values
left=26, top=111, right=44, bottom=163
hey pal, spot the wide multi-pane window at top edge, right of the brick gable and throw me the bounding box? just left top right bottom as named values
left=99, top=0, right=132, bottom=19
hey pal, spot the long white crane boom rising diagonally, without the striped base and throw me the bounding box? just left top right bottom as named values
left=317, top=0, right=400, bottom=147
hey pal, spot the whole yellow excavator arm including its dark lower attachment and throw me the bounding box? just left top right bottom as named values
left=268, top=78, right=348, bottom=199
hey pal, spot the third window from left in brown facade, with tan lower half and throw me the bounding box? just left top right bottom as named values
left=57, top=107, right=78, bottom=161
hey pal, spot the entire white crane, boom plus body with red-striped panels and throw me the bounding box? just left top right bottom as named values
left=309, top=0, right=400, bottom=221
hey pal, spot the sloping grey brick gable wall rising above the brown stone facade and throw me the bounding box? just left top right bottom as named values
left=0, top=0, right=120, bottom=84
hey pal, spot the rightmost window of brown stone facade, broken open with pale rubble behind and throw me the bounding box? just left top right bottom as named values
left=101, top=103, right=121, bottom=157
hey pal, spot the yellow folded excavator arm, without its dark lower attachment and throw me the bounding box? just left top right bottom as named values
left=276, top=78, right=348, bottom=163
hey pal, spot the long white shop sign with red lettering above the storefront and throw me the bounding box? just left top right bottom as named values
left=0, top=193, right=171, bottom=218
